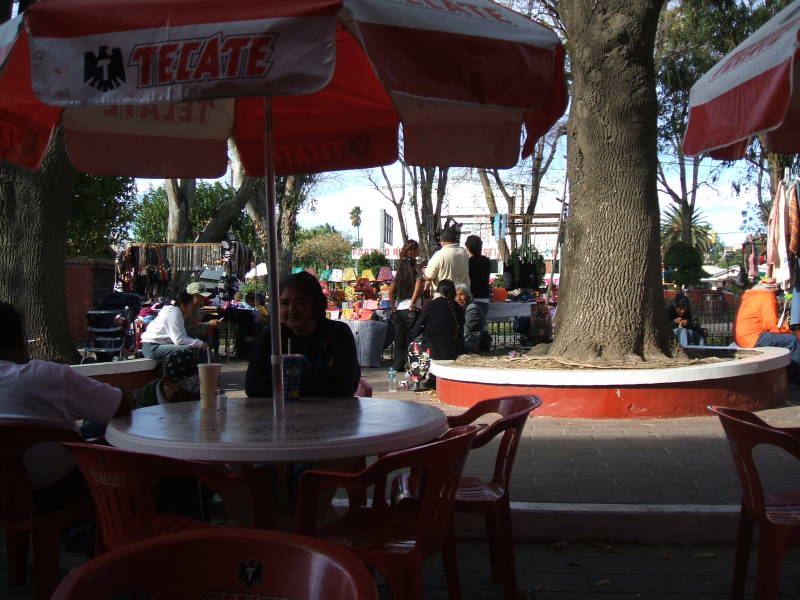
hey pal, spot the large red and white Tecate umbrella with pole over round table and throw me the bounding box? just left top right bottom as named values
left=0, top=0, right=567, bottom=414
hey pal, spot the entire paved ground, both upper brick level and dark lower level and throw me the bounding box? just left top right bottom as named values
left=0, top=363, right=800, bottom=600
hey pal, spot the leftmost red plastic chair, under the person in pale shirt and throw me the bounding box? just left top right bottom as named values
left=0, top=420, right=92, bottom=598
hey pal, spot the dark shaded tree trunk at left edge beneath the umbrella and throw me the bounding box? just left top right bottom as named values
left=0, top=130, right=79, bottom=363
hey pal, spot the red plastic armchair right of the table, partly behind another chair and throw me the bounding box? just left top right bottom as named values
left=392, top=396, right=542, bottom=600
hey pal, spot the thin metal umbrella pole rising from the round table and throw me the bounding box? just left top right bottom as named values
left=264, top=96, right=284, bottom=418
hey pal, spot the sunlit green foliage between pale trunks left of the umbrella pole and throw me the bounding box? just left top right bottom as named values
left=133, top=181, right=261, bottom=252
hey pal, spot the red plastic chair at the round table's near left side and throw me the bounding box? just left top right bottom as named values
left=64, top=443, right=272, bottom=554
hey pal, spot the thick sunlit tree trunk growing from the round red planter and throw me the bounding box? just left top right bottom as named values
left=550, top=0, right=681, bottom=363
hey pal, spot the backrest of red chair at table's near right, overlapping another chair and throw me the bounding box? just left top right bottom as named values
left=372, top=425, right=479, bottom=555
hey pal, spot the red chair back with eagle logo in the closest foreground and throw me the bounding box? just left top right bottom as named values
left=53, top=529, right=378, bottom=600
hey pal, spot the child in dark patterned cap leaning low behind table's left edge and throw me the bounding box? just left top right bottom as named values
left=131, top=350, right=200, bottom=408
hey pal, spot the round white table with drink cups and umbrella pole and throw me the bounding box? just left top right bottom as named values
left=106, top=398, right=447, bottom=463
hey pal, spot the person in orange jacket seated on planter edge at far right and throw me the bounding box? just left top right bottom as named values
left=734, top=278, right=800, bottom=366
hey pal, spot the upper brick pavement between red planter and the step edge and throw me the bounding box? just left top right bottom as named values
left=223, top=363, right=800, bottom=505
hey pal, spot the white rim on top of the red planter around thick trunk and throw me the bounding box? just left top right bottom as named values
left=431, top=346, right=791, bottom=387
